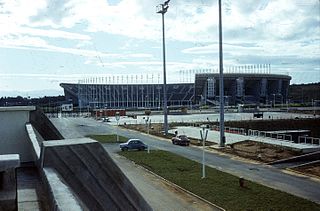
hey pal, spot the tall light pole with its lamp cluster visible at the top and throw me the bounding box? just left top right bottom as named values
left=157, top=0, right=170, bottom=135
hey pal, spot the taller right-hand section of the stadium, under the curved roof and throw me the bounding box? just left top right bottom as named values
left=194, top=73, right=291, bottom=105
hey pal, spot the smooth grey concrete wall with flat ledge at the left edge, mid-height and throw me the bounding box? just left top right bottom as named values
left=0, top=106, right=35, bottom=162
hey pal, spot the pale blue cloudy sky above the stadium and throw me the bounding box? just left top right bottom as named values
left=0, top=0, right=320, bottom=97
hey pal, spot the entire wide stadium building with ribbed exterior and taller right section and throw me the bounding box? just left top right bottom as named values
left=60, top=73, right=291, bottom=109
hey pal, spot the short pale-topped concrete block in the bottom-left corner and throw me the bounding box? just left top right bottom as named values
left=0, top=154, right=20, bottom=211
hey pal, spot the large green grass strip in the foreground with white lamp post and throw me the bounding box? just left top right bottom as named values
left=119, top=150, right=320, bottom=211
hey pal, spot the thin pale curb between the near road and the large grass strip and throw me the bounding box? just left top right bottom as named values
left=121, top=155, right=226, bottom=211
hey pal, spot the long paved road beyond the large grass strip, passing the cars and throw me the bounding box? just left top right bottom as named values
left=52, top=118, right=320, bottom=203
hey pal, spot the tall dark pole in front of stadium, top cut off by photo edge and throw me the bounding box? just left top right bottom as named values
left=219, top=0, right=226, bottom=147
